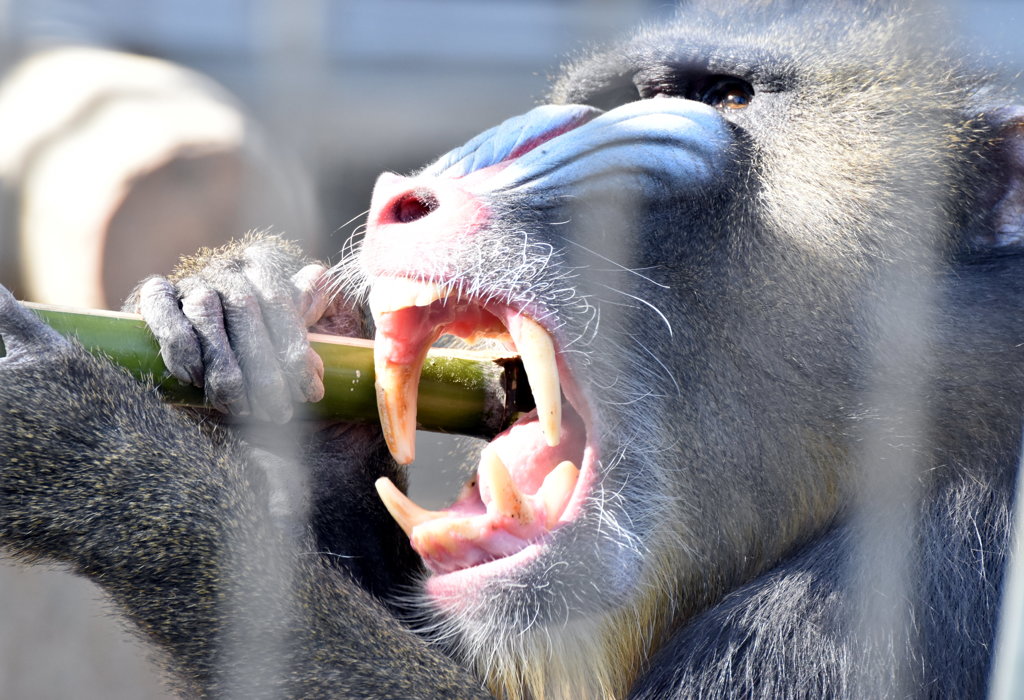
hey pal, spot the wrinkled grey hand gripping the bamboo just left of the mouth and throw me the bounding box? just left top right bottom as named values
left=127, top=235, right=362, bottom=423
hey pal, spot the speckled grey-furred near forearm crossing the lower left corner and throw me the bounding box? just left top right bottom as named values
left=0, top=288, right=482, bottom=697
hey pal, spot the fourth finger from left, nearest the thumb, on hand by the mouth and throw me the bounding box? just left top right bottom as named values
left=246, top=266, right=324, bottom=401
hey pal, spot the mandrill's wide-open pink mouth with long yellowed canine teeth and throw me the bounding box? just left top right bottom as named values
left=370, top=277, right=596, bottom=574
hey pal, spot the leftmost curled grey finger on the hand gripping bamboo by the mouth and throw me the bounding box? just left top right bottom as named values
left=138, top=277, right=204, bottom=387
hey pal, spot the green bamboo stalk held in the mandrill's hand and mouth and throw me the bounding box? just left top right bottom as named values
left=16, top=303, right=531, bottom=437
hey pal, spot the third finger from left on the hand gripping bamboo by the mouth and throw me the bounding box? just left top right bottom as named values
left=220, top=277, right=301, bottom=423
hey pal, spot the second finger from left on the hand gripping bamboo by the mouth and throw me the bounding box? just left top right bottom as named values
left=181, top=278, right=251, bottom=415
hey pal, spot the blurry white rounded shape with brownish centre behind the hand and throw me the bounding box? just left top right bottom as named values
left=0, top=47, right=322, bottom=308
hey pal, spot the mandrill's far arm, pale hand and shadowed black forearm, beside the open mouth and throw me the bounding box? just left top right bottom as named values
left=127, top=234, right=428, bottom=598
